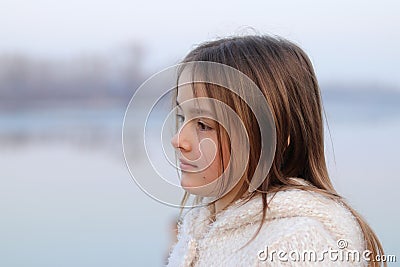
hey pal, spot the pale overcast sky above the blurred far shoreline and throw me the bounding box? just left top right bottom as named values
left=0, top=0, right=400, bottom=89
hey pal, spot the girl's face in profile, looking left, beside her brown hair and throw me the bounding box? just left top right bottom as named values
left=171, top=84, right=229, bottom=196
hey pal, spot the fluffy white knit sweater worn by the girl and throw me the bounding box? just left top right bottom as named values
left=168, top=179, right=366, bottom=267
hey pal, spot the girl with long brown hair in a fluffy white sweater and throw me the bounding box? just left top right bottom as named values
left=168, top=36, right=383, bottom=266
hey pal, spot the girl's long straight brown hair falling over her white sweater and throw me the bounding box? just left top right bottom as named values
left=174, top=36, right=386, bottom=266
